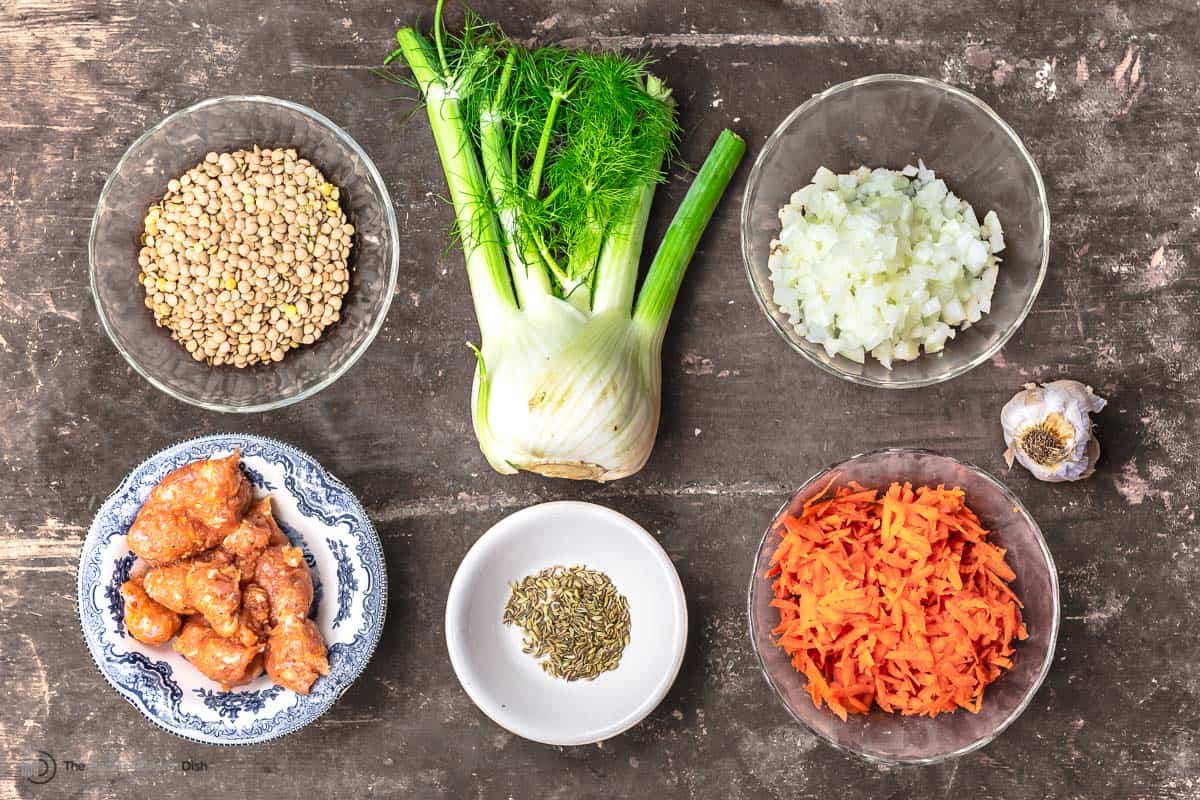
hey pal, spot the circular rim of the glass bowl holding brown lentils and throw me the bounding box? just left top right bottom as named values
left=88, top=95, right=400, bottom=414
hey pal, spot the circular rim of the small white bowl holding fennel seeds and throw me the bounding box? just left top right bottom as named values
left=444, top=500, right=688, bottom=747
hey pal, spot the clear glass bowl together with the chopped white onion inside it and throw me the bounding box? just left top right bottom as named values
left=742, top=74, right=1050, bottom=389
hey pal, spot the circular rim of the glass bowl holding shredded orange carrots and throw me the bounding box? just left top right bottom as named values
left=746, top=447, right=1062, bottom=766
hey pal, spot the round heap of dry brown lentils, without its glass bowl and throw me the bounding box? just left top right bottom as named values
left=138, top=145, right=354, bottom=367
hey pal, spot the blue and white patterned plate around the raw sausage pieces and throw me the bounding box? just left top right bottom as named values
left=79, top=434, right=388, bottom=745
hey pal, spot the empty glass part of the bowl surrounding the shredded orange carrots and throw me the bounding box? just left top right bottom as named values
left=749, top=450, right=1060, bottom=764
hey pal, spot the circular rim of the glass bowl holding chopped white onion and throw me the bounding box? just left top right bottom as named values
left=740, top=72, right=1050, bottom=389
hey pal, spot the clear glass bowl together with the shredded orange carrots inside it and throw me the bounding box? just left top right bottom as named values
left=749, top=449, right=1058, bottom=764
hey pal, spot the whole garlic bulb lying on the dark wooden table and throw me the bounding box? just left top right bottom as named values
left=1000, top=380, right=1106, bottom=482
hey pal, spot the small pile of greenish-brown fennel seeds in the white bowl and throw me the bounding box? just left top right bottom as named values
left=503, top=565, right=630, bottom=680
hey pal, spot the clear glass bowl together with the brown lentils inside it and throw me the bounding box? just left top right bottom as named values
left=88, top=96, right=400, bottom=411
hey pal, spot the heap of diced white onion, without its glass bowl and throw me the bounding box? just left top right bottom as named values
left=768, top=162, right=1004, bottom=368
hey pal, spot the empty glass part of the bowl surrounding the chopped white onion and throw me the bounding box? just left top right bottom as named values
left=742, top=74, right=1050, bottom=389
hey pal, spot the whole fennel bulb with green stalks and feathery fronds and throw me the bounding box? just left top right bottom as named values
left=394, top=12, right=745, bottom=481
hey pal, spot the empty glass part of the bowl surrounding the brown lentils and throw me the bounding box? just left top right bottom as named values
left=88, top=96, right=400, bottom=411
